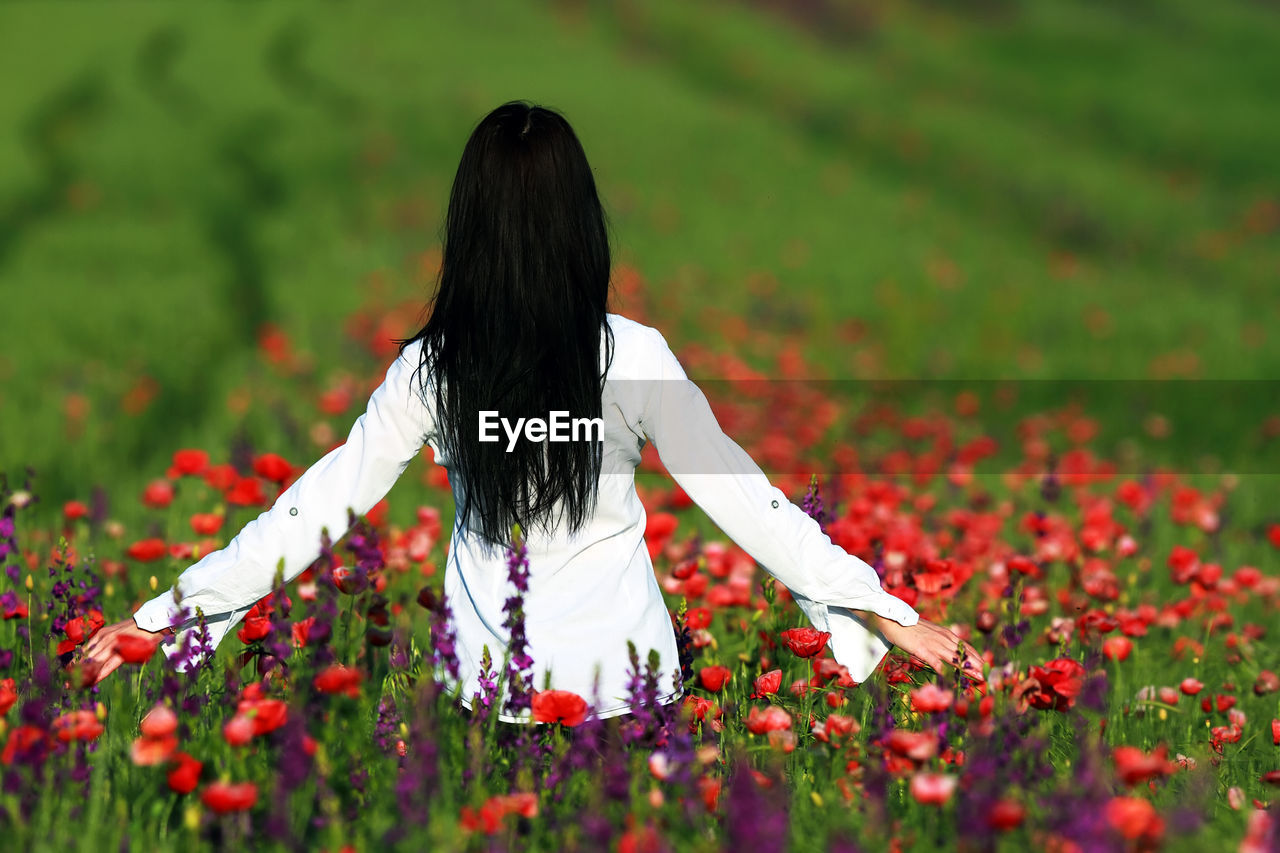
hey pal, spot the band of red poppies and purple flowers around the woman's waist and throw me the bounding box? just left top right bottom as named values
left=0, top=286, right=1280, bottom=852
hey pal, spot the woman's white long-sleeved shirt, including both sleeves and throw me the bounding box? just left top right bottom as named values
left=134, top=314, right=919, bottom=721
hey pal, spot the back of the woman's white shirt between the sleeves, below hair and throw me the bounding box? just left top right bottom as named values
left=435, top=308, right=678, bottom=719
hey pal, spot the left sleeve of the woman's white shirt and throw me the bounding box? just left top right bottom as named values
left=133, top=341, right=434, bottom=657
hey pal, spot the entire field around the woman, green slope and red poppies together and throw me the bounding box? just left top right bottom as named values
left=0, top=0, right=1280, bottom=853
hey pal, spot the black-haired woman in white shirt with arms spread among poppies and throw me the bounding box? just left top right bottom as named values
left=86, top=101, right=982, bottom=722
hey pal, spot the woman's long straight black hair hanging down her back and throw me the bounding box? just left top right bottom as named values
left=398, top=101, right=613, bottom=544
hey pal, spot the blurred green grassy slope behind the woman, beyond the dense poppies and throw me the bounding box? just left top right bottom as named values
left=0, top=0, right=1280, bottom=515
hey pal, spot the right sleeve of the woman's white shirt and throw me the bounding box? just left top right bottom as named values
left=640, top=329, right=920, bottom=681
